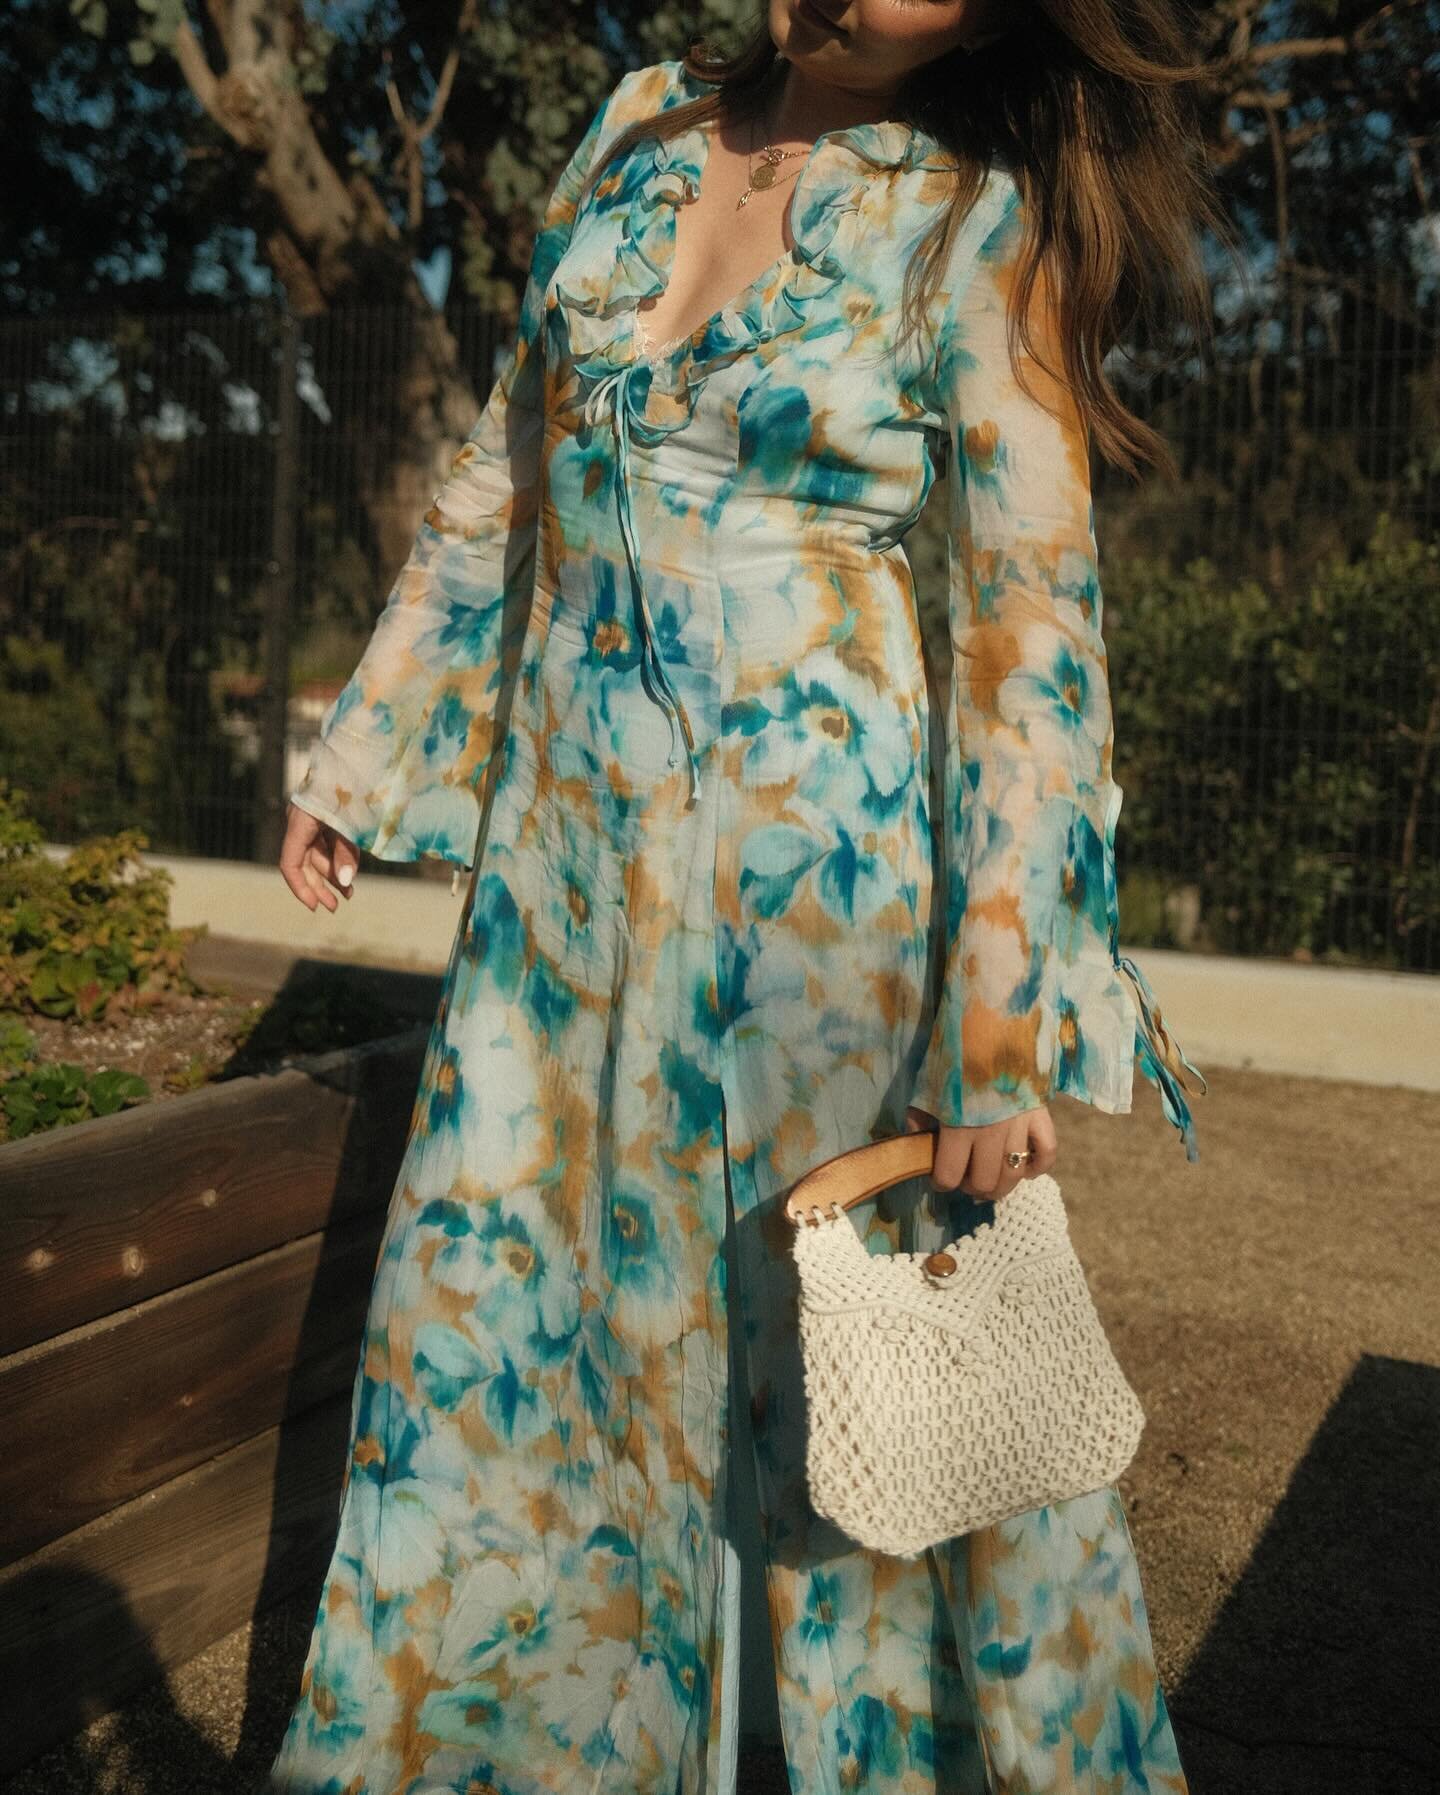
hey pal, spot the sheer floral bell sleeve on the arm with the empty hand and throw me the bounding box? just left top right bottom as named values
left=289, top=85, right=610, bottom=867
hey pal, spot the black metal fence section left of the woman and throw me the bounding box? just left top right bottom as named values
left=0, top=307, right=505, bottom=875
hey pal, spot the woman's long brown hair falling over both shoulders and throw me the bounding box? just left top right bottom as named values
left=578, top=0, right=1244, bottom=477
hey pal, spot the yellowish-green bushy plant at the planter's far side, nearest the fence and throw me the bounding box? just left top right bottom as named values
left=0, top=781, right=198, bottom=1020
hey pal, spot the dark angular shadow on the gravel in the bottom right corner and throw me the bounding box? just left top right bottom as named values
left=1171, top=1353, right=1440, bottom=1795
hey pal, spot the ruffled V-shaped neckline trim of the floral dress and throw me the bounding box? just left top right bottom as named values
left=555, top=65, right=948, bottom=434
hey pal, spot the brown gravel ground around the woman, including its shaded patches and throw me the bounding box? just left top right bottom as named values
left=5, top=1072, right=1440, bottom=1795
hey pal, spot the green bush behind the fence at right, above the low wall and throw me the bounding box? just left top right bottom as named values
left=1104, top=515, right=1440, bottom=969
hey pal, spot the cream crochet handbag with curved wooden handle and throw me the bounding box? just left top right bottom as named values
left=785, top=1131, right=1146, bottom=1558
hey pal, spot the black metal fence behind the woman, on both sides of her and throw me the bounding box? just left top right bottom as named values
left=0, top=285, right=1440, bottom=968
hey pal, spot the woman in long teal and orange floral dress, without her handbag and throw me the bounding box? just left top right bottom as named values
left=271, top=0, right=1208, bottom=1795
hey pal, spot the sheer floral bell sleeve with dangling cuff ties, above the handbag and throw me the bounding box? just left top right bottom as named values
left=912, top=183, right=1205, bottom=1160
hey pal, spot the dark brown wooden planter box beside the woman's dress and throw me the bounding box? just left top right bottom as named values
left=0, top=1027, right=427, bottom=1775
